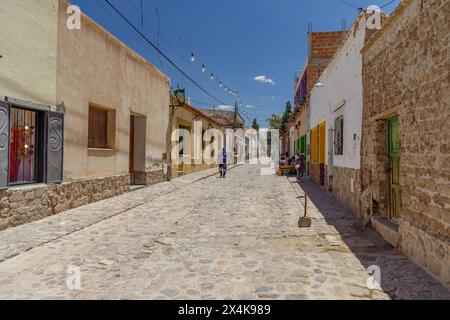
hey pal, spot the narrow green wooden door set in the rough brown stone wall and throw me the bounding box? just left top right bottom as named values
left=388, top=116, right=402, bottom=219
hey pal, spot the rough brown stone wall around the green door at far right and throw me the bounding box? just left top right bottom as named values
left=361, top=0, right=450, bottom=287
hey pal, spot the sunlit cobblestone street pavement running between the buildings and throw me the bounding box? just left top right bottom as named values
left=0, top=166, right=450, bottom=299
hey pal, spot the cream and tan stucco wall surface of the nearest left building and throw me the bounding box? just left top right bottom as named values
left=0, top=0, right=170, bottom=182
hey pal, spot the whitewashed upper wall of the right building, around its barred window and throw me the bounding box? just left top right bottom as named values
left=309, top=14, right=366, bottom=169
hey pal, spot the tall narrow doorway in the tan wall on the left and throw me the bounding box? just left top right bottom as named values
left=128, top=114, right=147, bottom=186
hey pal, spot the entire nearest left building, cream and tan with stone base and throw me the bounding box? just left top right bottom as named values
left=0, top=0, right=170, bottom=230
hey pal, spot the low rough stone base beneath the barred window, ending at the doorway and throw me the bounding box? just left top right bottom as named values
left=0, top=174, right=130, bottom=230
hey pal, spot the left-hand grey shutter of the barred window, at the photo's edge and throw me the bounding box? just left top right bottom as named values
left=0, top=101, right=10, bottom=190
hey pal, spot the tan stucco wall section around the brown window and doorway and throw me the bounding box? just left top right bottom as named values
left=57, top=0, right=170, bottom=181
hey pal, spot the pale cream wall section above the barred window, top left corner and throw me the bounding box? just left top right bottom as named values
left=0, top=0, right=58, bottom=105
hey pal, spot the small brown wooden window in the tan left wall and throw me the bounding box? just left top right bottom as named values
left=88, top=106, right=115, bottom=149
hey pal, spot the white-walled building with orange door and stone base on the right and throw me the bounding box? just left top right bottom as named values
left=309, top=11, right=372, bottom=216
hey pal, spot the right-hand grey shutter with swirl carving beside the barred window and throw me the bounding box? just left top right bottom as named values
left=45, top=111, right=64, bottom=183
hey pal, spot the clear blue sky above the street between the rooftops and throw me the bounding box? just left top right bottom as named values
left=71, top=0, right=400, bottom=126
